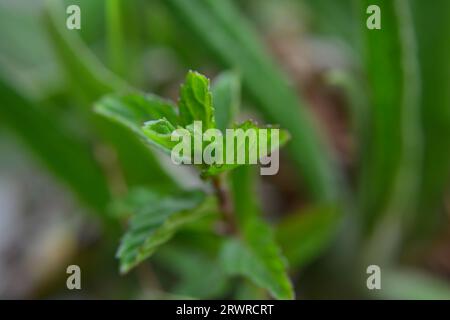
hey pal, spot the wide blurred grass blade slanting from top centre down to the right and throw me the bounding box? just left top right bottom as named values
left=166, top=0, right=340, bottom=200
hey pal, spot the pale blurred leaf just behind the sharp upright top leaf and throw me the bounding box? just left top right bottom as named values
left=211, top=71, right=241, bottom=132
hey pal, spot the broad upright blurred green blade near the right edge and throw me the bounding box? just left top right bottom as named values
left=360, top=0, right=421, bottom=239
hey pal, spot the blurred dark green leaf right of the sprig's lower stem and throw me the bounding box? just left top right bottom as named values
left=276, top=206, right=340, bottom=268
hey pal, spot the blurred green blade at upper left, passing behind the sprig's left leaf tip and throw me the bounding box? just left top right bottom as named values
left=45, top=0, right=173, bottom=186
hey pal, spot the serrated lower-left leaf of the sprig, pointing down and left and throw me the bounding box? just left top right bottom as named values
left=117, top=190, right=215, bottom=273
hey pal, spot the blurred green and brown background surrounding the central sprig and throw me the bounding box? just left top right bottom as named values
left=0, top=0, right=450, bottom=299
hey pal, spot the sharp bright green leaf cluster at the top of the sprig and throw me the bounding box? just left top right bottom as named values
left=95, top=71, right=289, bottom=177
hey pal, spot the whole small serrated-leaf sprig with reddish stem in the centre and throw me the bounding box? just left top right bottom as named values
left=95, top=71, right=294, bottom=299
